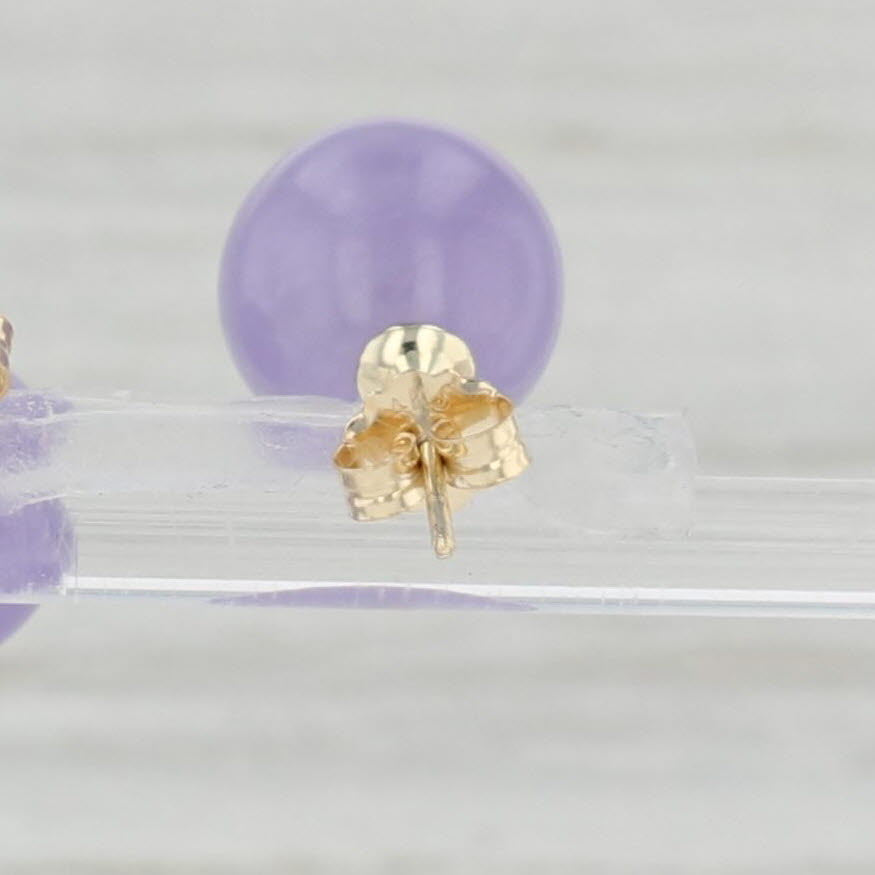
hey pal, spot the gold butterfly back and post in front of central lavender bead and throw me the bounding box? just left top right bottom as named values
left=334, top=325, right=529, bottom=559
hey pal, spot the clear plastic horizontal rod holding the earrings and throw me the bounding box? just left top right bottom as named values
left=0, top=391, right=875, bottom=616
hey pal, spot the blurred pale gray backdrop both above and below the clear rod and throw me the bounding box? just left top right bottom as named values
left=0, top=0, right=875, bottom=875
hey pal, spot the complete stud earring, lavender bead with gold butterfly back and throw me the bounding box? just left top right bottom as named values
left=219, top=120, right=562, bottom=556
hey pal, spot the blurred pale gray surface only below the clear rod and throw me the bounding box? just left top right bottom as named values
left=8, top=606, right=875, bottom=875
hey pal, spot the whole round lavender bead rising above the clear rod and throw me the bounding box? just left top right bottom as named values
left=219, top=121, right=561, bottom=401
